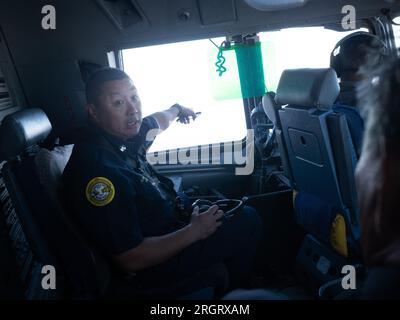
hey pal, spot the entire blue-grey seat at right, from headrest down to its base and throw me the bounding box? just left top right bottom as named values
left=276, top=69, right=360, bottom=292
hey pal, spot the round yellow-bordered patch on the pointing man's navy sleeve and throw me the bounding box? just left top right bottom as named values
left=86, top=177, right=115, bottom=207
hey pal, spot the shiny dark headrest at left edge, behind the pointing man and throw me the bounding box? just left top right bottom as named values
left=0, top=108, right=51, bottom=160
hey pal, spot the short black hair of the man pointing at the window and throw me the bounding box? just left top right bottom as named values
left=86, top=67, right=129, bottom=104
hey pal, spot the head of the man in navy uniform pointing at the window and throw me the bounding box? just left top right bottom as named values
left=86, top=67, right=142, bottom=139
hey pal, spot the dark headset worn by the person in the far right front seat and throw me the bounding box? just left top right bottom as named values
left=330, top=31, right=388, bottom=78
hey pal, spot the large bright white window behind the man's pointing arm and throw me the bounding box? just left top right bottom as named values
left=122, top=38, right=246, bottom=152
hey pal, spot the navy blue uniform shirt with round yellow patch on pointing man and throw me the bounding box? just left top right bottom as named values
left=62, top=117, right=182, bottom=256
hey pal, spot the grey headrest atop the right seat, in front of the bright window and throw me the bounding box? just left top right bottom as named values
left=276, top=68, right=340, bottom=108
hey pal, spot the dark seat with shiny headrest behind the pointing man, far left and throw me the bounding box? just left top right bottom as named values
left=0, top=109, right=107, bottom=299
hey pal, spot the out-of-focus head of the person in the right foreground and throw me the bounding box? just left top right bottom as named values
left=356, top=59, right=400, bottom=266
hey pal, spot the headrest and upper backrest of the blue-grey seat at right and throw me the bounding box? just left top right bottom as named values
left=277, top=69, right=359, bottom=243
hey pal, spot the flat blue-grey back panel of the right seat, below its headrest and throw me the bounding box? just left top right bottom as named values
left=280, top=106, right=343, bottom=207
